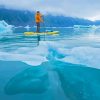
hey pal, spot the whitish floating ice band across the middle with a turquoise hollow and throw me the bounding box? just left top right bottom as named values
left=0, top=41, right=100, bottom=69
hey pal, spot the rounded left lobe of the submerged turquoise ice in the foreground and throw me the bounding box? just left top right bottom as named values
left=5, top=67, right=49, bottom=94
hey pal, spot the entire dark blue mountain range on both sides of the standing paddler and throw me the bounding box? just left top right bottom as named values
left=0, top=7, right=96, bottom=27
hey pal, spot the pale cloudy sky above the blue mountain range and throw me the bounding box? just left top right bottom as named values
left=0, top=0, right=100, bottom=20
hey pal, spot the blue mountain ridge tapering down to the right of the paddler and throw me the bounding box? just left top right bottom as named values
left=45, top=15, right=93, bottom=27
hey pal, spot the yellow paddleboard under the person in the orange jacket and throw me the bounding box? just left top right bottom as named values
left=24, top=31, right=59, bottom=36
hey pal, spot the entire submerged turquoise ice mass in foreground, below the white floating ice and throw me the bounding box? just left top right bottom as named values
left=5, top=61, right=100, bottom=100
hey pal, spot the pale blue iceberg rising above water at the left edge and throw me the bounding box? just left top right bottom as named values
left=0, top=20, right=13, bottom=34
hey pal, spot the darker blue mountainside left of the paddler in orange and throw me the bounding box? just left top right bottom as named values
left=0, top=8, right=33, bottom=26
